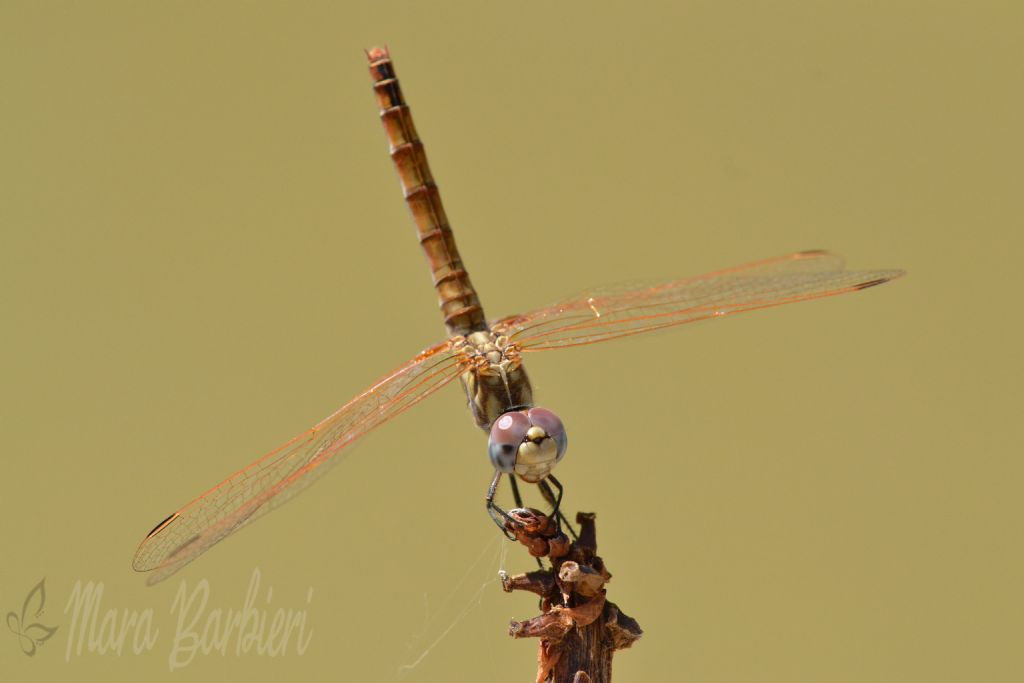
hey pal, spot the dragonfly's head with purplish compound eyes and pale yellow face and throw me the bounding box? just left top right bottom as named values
left=487, top=408, right=568, bottom=483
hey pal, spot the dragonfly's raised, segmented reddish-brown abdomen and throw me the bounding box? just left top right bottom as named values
left=367, top=48, right=487, bottom=336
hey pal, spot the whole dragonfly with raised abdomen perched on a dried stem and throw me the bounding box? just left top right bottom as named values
left=132, top=48, right=903, bottom=584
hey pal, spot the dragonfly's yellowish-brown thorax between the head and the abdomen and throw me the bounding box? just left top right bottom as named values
left=453, top=330, right=534, bottom=430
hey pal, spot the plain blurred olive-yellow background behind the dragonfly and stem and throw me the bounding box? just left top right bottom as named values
left=0, top=0, right=1024, bottom=683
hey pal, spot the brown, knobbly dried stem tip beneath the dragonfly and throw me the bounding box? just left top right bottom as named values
left=501, top=508, right=643, bottom=683
